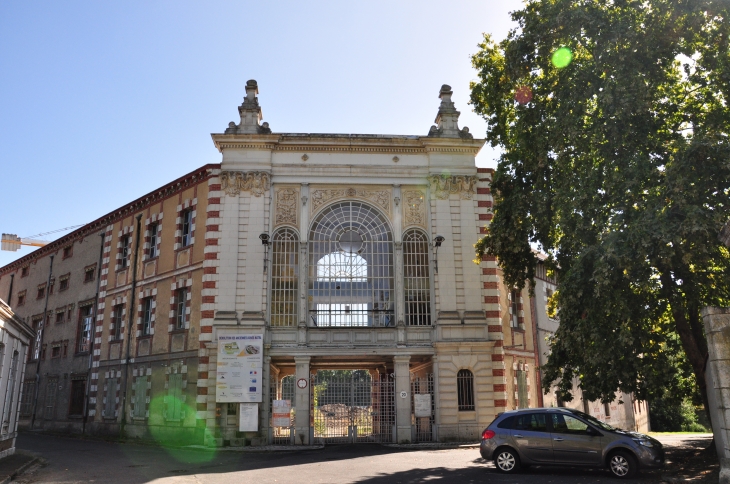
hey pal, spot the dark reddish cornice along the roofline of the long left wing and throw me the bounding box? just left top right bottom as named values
left=0, top=163, right=221, bottom=275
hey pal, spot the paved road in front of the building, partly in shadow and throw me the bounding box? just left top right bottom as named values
left=16, top=433, right=709, bottom=484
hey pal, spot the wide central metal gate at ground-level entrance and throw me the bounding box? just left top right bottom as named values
left=310, top=370, right=395, bottom=443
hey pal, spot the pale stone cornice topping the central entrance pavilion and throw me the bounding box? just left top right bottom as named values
left=211, top=133, right=485, bottom=155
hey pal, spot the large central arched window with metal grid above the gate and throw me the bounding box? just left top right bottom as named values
left=309, top=201, right=395, bottom=327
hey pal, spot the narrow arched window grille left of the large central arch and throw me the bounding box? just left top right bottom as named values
left=271, top=228, right=299, bottom=326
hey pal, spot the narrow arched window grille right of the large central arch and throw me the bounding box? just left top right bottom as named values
left=403, top=230, right=431, bottom=326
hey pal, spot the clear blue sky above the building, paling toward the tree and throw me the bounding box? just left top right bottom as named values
left=0, top=0, right=521, bottom=266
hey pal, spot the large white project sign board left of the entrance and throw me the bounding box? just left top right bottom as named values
left=215, top=334, right=264, bottom=403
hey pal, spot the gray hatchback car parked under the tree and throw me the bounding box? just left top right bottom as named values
left=479, top=407, right=664, bottom=478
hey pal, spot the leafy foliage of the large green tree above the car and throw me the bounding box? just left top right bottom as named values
left=471, top=0, right=730, bottom=416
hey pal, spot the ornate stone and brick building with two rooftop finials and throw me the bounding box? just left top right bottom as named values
left=0, top=81, right=616, bottom=445
